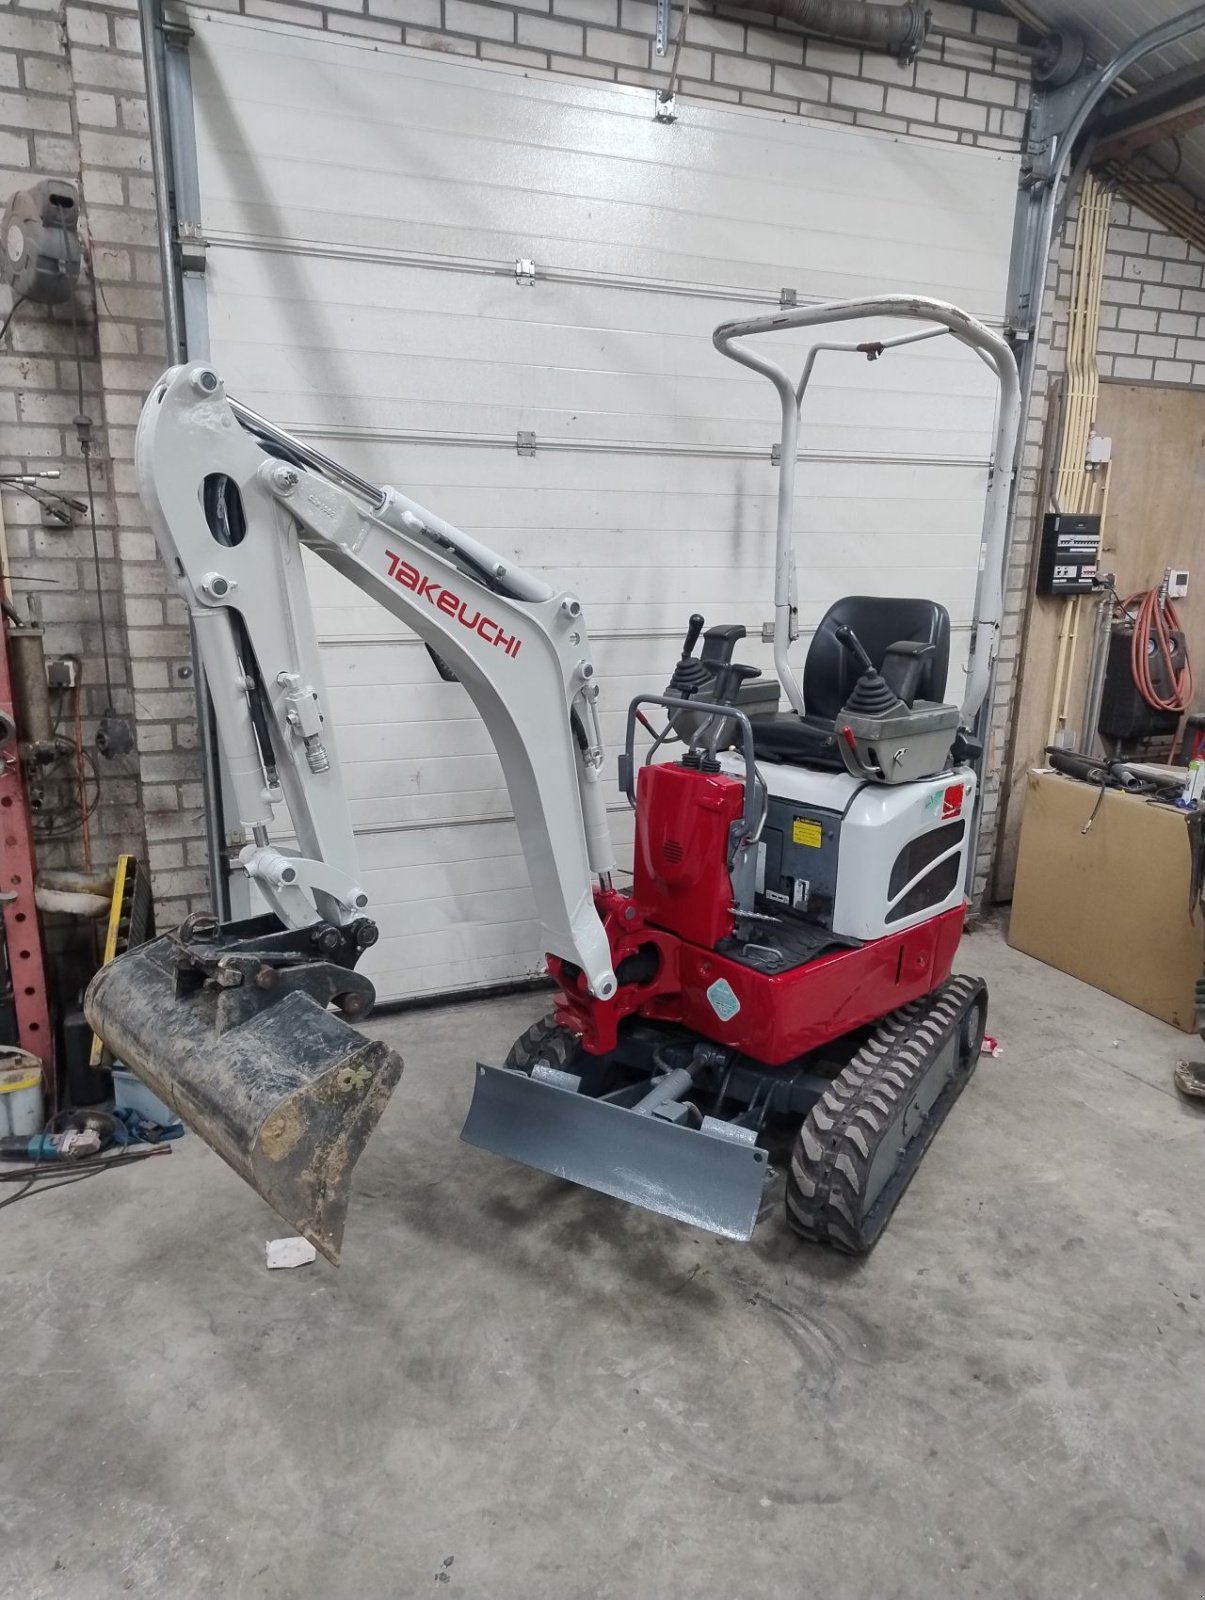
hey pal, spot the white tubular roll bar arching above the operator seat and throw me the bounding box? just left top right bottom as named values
left=712, top=294, right=1021, bottom=726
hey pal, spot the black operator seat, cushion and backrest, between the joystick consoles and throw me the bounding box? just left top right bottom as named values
left=752, top=595, right=951, bottom=766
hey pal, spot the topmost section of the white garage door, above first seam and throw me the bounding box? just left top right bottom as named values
left=194, top=21, right=1015, bottom=300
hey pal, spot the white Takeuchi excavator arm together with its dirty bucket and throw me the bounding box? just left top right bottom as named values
left=85, top=365, right=616, bottom=1261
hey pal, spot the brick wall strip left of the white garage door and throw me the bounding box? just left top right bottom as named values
left=0, top=0, right=214, bottom=922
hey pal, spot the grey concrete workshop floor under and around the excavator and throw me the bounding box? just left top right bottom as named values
left=0, top=930, right=1205, bottom=1600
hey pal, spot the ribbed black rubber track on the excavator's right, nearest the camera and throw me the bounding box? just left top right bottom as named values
left=786, top=978, right=986, bottom=1254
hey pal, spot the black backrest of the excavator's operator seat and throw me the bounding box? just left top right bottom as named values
left=803, top=595, right=951, bottom=718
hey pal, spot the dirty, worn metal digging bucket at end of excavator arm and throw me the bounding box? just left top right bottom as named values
left=83, top=939, right=402, bottom=1266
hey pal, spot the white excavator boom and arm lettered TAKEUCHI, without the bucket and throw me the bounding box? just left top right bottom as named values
left=136, top=363, right=616, bottom=998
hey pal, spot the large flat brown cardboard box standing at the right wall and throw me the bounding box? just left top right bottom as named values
left=1008, top=771, right=1205, bottom=1034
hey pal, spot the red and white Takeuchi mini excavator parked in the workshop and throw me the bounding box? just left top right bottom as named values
left=85, top=294, right=1019, bottom=1261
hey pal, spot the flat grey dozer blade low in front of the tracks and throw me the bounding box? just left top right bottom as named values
left=461, top=1064, right=767, bottom=1238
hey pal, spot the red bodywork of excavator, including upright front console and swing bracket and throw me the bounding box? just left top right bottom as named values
left=549, top=752, right=965, bottom=1067
